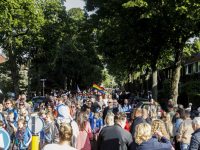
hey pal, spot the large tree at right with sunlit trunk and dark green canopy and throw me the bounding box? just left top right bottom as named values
left=123, top=0, right=200, bottom=104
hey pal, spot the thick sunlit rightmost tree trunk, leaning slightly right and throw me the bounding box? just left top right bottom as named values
left=172, top=47, right=183, bottom=105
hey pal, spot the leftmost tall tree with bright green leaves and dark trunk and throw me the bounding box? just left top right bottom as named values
left=0, top=0, right=50, bottom=95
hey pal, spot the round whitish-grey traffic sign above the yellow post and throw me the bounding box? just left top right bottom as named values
left=27, top=116, right=44, bottom=134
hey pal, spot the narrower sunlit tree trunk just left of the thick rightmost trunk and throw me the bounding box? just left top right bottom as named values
left=151, top=61, right=158, bottom=101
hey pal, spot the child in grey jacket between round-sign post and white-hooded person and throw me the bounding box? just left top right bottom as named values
left=43, top=112, right=59, bottom=144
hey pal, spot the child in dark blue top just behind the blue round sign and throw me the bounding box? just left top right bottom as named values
left=5, top=111, right=17, bottom=149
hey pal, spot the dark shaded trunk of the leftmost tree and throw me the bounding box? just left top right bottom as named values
left=8, top=39, right=19, bottom=96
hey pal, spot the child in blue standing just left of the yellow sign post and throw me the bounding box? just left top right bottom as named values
left=14, top=119, right=32, bottom=149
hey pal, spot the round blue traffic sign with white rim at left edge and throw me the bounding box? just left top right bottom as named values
left=0, top=129, right=11, bottom=150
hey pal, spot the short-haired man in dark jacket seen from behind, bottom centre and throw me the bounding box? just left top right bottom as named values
left=97, top=112, right=133, bottom=150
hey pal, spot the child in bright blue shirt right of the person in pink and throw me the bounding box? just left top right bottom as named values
left=94, top=112, right=103, bottom=140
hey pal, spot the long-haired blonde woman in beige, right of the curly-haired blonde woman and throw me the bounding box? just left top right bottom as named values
left=162, top=112, right=176, bottom=143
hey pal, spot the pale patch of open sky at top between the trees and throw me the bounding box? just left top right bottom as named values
left=65, top=0, right=85, bottom=10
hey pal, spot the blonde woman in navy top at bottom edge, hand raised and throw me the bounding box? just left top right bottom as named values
left=131, top=123, right=172, bottom=150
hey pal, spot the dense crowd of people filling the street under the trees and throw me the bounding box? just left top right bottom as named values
left=0, top=91, right=200, bottom=150
